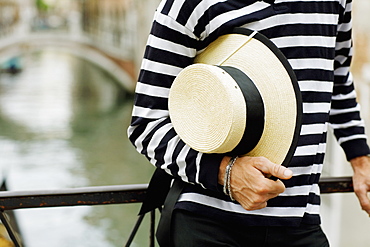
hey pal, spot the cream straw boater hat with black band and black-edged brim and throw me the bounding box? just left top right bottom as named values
left=169, top=28, right=302, bottom=165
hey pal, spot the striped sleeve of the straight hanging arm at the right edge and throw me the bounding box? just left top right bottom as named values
left=330, top=0, right=370, bottom=160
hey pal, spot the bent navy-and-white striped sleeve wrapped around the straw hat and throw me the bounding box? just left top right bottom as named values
left=128, top=1, right=222, bottom=190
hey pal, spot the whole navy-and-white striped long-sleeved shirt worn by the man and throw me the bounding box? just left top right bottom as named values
left=128, top=0, right=369, bottom=226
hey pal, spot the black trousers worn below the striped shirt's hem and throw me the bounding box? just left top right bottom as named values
left=171, top=210, right=329, bottom=247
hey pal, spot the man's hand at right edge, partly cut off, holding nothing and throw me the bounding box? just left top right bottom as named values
left=350, top=156, right=370, bottom=216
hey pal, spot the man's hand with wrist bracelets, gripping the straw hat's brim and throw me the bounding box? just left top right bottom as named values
left=218, top=156, right=293, bottom=210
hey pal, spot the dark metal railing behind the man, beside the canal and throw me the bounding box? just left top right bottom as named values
left=0, top=177, right=353, bottom=247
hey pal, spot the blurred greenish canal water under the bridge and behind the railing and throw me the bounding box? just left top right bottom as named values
left=0, top=50, right=153, bottom=247
